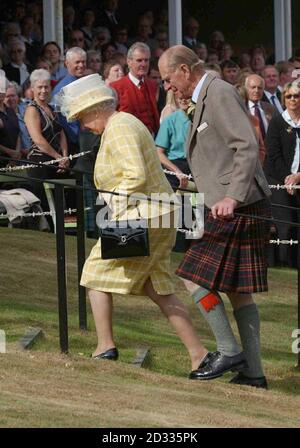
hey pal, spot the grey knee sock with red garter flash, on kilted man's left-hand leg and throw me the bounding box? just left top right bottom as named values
left=192, top=286, right=242, bottom=356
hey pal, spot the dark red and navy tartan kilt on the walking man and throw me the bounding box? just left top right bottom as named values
left=176, top=199, right=271, bottom=294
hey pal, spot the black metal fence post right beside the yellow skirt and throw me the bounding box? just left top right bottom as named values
left=75, top=172, right=87, bottom=330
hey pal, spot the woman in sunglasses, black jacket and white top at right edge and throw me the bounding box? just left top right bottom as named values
left=266, top=81, right=300, bottom=267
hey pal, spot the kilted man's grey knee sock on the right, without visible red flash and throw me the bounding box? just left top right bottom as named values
left=233, top=303, right=264, bottom=378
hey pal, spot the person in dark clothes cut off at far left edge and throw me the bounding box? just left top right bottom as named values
left=0, top=70, right=21, bottom=167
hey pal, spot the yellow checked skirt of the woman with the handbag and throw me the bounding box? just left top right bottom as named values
left=80, top=228, right=176, bottom=295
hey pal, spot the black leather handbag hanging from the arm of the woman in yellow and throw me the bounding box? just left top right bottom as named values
left=99, top=219, right=150, bottom=260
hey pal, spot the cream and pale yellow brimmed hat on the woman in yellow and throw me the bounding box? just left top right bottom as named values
left=55, top=74, right=115, bottom=121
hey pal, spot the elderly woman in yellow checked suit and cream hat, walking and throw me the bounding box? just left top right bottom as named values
left=59, top=74, right=208, bottom=370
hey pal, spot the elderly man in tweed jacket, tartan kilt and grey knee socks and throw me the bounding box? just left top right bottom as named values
left=159, top=45, right=270, bottom=388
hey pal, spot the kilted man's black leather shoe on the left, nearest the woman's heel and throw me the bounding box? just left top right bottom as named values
left=189, top=351, right=248, bottom=380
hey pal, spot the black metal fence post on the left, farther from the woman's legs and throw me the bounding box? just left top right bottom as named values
left=55, top=184, right=69, bottom=353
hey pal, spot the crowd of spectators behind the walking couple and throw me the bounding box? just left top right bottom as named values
left=0, top=0, right=300, bottom=263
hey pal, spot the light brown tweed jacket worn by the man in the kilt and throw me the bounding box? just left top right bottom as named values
left=187, top=75, right=271, bottom=208
